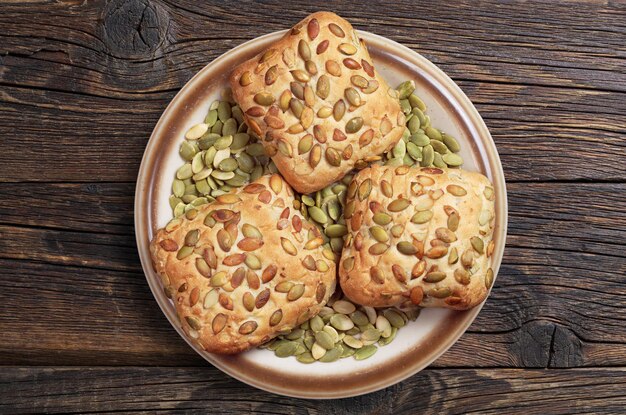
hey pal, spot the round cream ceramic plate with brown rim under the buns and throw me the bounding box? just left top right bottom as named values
left=135, top=31, right=507, bottom=398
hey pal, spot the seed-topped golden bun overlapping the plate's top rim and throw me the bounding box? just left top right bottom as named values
left=230, top=12, right=405, bottom=193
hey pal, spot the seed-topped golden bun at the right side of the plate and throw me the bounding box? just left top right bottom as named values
left=339, top=166, right=495, bottom=310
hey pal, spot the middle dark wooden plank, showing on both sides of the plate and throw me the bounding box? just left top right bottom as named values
left=0, top=183, right=626, bottom=367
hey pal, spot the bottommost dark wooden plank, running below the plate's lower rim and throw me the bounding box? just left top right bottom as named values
left=0, top=367, right=626, bottom=415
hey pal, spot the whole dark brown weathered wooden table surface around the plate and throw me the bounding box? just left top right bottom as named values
left=0, top=0, right=626, bottom=414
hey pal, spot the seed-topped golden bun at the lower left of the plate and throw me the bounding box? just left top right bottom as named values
left=150, top=174, right=336, bottom=353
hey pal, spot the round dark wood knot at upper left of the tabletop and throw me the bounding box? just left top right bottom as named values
left=101, top=0, right=170, bottom=58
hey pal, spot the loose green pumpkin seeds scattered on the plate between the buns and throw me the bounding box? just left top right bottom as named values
left=169, top=81, right=463, bottom=363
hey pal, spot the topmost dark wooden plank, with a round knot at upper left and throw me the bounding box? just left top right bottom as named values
left=0, top=0, right=626, bottom=181
